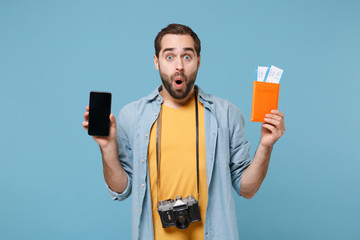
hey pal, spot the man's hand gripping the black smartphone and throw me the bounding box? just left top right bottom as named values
left=83, top=106, right=116, bottom=150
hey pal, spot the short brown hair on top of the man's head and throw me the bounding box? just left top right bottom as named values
left=154, top=23, right=201, bottom=57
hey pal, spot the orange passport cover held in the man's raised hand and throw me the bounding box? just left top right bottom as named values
left=250, top=81, right=280, bottom=122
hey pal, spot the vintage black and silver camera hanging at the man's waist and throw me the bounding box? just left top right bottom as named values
left=158, top=195, right=201, bottom=229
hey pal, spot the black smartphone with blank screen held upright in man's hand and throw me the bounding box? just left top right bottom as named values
left=88, top=91, right=111, bottom=136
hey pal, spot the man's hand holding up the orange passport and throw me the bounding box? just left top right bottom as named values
left=260, top=110, right=285, bottom=147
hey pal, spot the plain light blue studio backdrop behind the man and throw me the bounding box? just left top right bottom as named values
left=0, top=0, right=360, bottom=239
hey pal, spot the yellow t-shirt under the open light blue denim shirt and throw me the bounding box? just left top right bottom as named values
left=148, top=95, right=207, bottom=240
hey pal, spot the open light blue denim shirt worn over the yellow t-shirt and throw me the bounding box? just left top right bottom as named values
left=108, top=86, right=252, bottom=240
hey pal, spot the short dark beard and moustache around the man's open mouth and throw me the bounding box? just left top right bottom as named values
left=159, top=65, right=197, bottom=99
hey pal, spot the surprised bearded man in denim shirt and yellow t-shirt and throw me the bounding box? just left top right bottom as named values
left=83, top=24, right=285, bottom=239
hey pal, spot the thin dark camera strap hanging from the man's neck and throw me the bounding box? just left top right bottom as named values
left=156, top=90, right=200, bottom=202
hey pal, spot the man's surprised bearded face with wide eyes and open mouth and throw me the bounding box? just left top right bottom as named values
left=154, top=34, right=200, bottom=99
